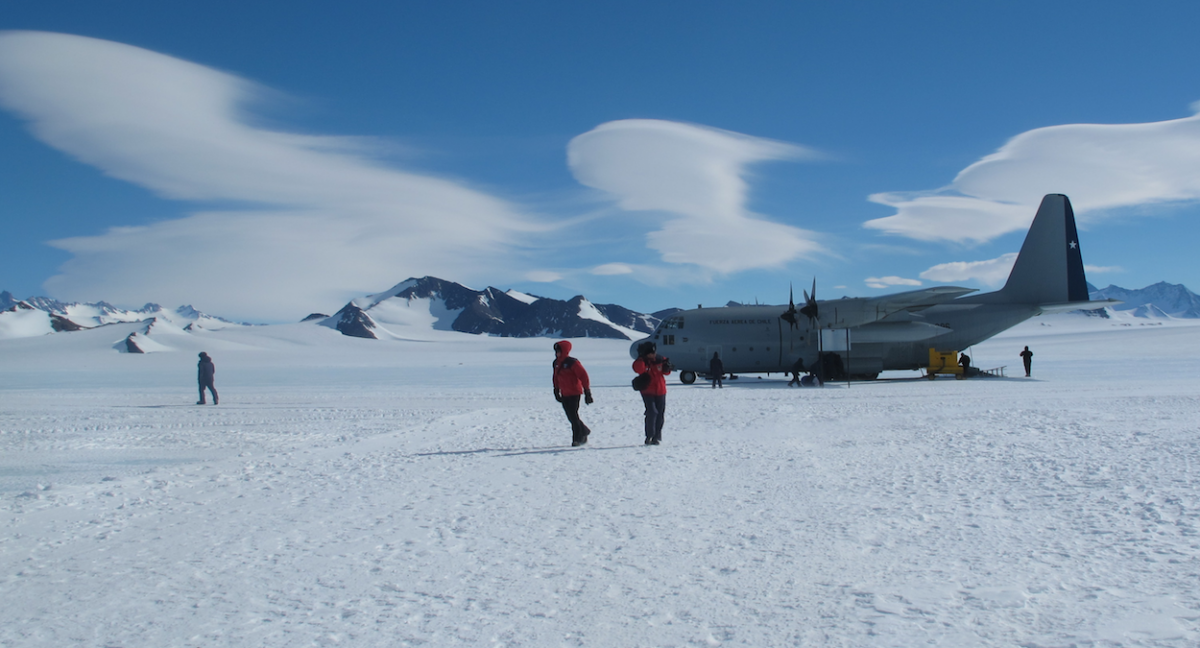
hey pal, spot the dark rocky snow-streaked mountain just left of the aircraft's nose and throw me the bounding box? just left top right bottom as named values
left=320, top=277, right=659, bottom=340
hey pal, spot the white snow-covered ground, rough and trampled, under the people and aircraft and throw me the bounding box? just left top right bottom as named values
left=0, top=316, right=1200, bottom=648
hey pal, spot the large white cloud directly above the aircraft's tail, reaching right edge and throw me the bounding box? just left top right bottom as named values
left=865, top=104, right=1200, bottom=242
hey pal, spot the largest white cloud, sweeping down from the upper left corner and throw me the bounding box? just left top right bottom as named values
left=0, top=31, right=539, bottom=319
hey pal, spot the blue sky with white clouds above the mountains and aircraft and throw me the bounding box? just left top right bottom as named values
left=0, top=1, right=1200, bottom=322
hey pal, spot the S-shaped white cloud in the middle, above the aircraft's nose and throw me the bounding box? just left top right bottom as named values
left=568, top=119, right=821, bottom=274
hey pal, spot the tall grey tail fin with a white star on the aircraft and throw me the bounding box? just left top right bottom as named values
left=1000, top=193, right=1088, bottom=305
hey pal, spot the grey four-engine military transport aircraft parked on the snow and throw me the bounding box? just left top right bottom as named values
left=629, top=193, right=1118, bottom=384
